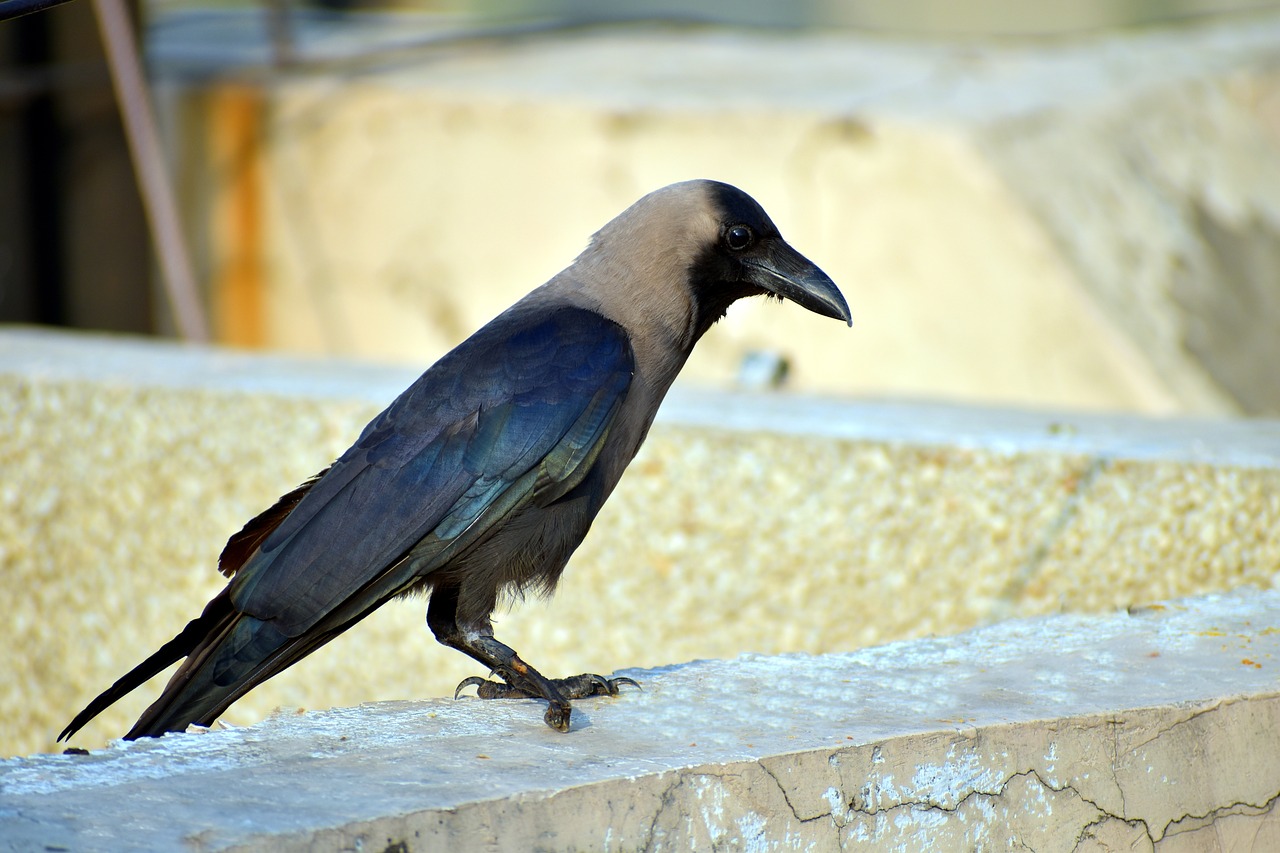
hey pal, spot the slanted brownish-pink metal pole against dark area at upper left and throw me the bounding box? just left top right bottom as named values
left=91, top=0, right=209, bottom=343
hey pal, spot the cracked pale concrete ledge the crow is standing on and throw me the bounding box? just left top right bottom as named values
left=0, top=590, right=1280, bottom=852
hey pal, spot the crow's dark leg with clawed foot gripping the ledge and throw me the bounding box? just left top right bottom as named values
left=426, top=588, right=640, bottom=731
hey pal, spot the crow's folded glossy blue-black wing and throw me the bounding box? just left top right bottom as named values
left=232, top=307, right=634, bottom=637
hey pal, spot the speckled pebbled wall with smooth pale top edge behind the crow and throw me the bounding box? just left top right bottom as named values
left=0, top=329, right=1280, bottom=754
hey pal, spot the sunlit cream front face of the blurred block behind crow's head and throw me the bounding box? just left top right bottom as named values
left=249, top=90, right=1172, bottom=409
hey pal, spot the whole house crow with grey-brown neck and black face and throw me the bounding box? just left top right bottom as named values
left=59, top=175, right=850, bottom=740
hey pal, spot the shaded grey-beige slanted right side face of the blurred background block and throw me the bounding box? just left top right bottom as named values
left=983, top=64, right=1280, bottom=414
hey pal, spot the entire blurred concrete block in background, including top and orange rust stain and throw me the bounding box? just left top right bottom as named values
left=151, top=14, right=1280, bottom=414
